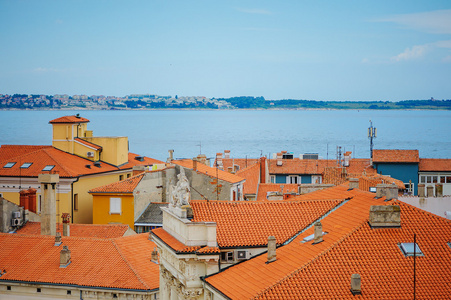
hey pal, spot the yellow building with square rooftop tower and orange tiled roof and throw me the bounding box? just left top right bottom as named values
left=0, top=115, right=162, bottom=223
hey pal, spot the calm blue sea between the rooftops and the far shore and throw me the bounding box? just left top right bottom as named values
left=0, top=110, right=451, bottom=160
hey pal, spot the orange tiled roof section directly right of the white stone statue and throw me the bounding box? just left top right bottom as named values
left=191, top=200, right=341, bottom=248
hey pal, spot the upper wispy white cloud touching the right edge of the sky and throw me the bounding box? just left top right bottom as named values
left=375, top=9, right=451, bottom=34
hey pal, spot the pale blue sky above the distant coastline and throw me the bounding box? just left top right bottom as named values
left=0, top=0, right=451, bottom=101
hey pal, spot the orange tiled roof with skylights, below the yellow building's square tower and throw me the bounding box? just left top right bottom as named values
left=0, top=145, right=163, bottom=178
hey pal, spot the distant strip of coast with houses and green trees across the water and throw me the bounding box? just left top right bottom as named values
left=0, top=94, right=451, bottom=110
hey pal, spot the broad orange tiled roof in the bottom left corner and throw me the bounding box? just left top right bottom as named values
left=0, top=233, right=159, bottom=291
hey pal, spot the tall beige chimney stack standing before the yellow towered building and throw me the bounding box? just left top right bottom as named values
left=38, top=174, right=59, bottom=235
